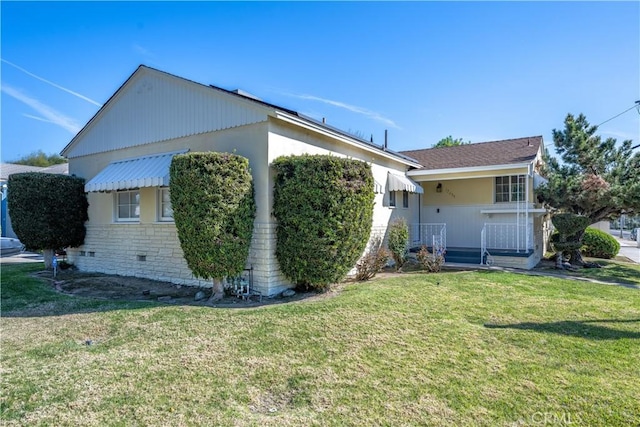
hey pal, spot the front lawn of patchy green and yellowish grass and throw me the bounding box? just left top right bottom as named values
left=0, top=265, right=640, bottom=426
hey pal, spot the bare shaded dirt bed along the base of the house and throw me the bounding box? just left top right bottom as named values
left=34, top=269, right=342, bottom=307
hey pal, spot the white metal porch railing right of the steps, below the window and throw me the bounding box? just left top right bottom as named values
left=480, top=223, right=533, bottom=264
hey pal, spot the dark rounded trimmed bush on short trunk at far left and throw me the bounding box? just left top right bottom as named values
left=7, top=172, right=89, bottom=268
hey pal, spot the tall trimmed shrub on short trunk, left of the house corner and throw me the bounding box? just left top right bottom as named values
left=169, top=152, right=256, bottom=301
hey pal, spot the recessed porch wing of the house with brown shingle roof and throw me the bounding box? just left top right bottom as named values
left=402, top=136, right=550, bottom=269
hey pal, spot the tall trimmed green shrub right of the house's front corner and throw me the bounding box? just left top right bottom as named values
left=273, top=155, right=374, bottom=290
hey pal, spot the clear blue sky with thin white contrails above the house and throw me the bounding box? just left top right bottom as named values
left=0, top=1, right=640, bottom=161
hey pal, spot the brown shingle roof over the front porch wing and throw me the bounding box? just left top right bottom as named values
left=401, top=136, right=542, bottom=171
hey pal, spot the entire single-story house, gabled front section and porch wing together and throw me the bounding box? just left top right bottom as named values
left=61, top=65, right=545, bottom=295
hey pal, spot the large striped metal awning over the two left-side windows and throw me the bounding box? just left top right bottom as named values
left=84, top=150, right=188, bottom=192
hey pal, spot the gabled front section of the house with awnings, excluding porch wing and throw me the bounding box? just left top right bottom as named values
left=61, top=66, right=423, bottom=295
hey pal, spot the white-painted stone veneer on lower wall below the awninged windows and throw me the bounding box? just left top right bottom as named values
left=67, top=223, right=292, bottom=296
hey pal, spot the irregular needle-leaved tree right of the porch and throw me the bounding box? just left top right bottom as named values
left=537, top=114, right=640, bottom=265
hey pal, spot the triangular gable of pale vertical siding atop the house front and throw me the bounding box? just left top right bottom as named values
left=65, top=68, right=268, bottom=158
